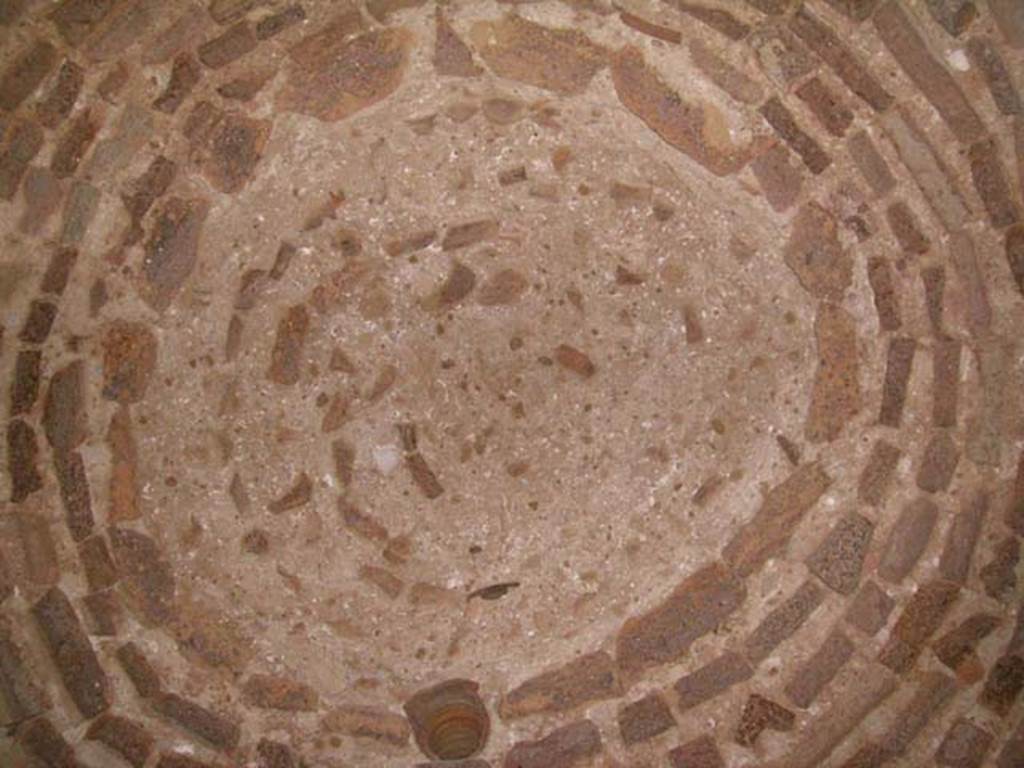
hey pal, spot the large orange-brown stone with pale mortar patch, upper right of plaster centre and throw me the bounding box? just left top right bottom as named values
left=611, top=45, right=756, bottom=176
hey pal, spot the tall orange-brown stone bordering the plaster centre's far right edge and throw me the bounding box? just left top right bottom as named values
left=805, top=302, right=862, bottom=442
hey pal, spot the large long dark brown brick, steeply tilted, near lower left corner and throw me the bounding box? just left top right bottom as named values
left=32, top=587, right=111, bottom=718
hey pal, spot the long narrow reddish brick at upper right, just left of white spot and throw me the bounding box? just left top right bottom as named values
left=873, top=0, right=985, bottom=144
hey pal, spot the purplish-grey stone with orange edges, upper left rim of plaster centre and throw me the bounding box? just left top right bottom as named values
left=140, top=197, right=209, bottom=312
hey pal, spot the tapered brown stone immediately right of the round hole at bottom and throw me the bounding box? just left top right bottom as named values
left=499, top=651, right=622, bottom=720
